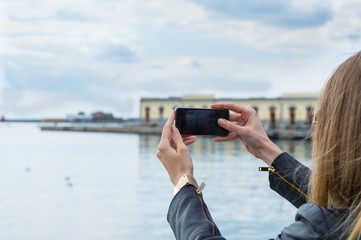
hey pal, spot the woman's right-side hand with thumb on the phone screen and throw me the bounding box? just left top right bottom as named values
left=211, top=103, right=282, bottom=166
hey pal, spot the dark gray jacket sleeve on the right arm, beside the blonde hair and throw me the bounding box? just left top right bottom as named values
left=269, top=153, right=311, bottom=208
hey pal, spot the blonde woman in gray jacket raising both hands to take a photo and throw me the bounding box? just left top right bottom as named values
left=157, top=52, right=361, bottom=240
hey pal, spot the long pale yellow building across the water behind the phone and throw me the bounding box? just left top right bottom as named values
left=140, top=93, right=319, bottom=127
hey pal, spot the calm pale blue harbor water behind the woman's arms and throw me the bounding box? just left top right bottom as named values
left=0, top=123, right=310, bottom=240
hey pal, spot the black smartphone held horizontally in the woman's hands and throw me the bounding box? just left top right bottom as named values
left=175, top=107, right=229, bottom=136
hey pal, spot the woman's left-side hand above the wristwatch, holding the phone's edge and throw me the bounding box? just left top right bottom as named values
left=157, top=111, right=196, bottom=185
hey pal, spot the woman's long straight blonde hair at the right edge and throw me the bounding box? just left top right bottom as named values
left=308, top=51, right=361, bottom=240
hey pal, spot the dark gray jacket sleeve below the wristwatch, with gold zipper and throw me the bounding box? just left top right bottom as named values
left=167, top=186, right=225, bottom=240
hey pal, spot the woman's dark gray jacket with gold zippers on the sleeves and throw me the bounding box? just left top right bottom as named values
left=167, top=153, right=348, bottom=240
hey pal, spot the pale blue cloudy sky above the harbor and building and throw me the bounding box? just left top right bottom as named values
left=0, top=0, right=361, bottom=118
